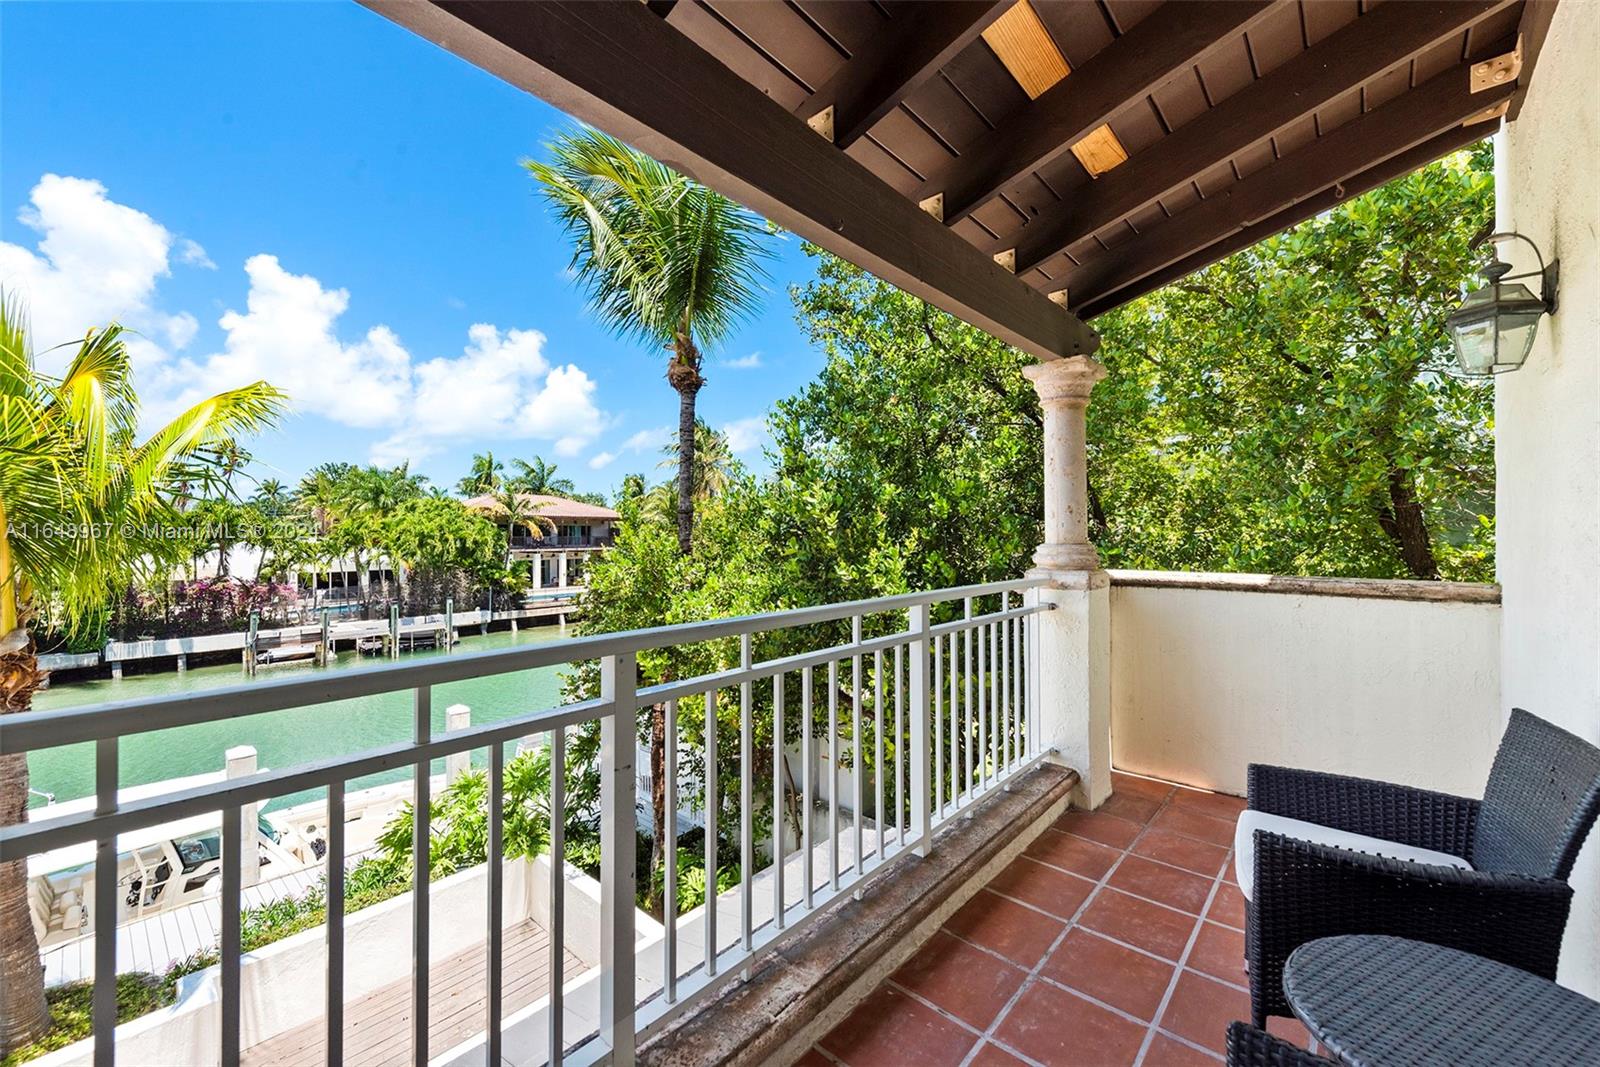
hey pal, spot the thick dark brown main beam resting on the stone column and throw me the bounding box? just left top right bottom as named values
left=363, top=0, right=1099, bottom=360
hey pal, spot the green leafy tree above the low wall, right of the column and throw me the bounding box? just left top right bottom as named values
left=1088, top=149, right=1494, bottom=579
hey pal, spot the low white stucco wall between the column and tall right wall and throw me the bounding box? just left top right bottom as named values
left=1110, top=574, right=1502, bottom=797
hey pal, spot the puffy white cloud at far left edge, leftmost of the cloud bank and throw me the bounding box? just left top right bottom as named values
left=0, top=174, right=197, bottom=371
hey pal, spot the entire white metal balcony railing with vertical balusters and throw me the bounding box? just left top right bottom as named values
left=0, top=581, right=1048, bottom=1067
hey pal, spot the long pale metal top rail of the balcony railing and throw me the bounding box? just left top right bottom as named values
left=0, top=577, right=1043, bottom=753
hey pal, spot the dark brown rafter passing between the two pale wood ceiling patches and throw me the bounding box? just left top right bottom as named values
left=915, top=0, right=1277, bottom=226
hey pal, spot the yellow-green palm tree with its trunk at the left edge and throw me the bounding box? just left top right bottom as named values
left=0, top=293, right=283, bottom=1054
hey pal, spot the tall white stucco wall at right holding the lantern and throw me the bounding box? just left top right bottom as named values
left=1494, top=3, right=1600, bottom=997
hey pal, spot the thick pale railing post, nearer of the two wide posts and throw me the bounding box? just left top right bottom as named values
left=600, top=653, right=638, bottom=1067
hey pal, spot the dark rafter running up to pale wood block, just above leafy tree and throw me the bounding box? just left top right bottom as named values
left=1067, top=58, right=1517, bottom=309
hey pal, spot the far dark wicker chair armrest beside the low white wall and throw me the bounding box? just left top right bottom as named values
left=1250, top=763, right=1478, bottom=856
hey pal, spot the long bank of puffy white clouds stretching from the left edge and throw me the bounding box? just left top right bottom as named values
left=0, top=174, right=610, bottom=462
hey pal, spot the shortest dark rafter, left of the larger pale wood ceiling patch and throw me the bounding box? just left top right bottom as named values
left=795, top=0, right=1011, bottom=149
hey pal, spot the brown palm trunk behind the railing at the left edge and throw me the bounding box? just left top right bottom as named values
left=0, top=630, right=50, bottom=1054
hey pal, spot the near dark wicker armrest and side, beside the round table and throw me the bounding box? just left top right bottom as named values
left=1246, top=832, right=1573, bottom=1022
